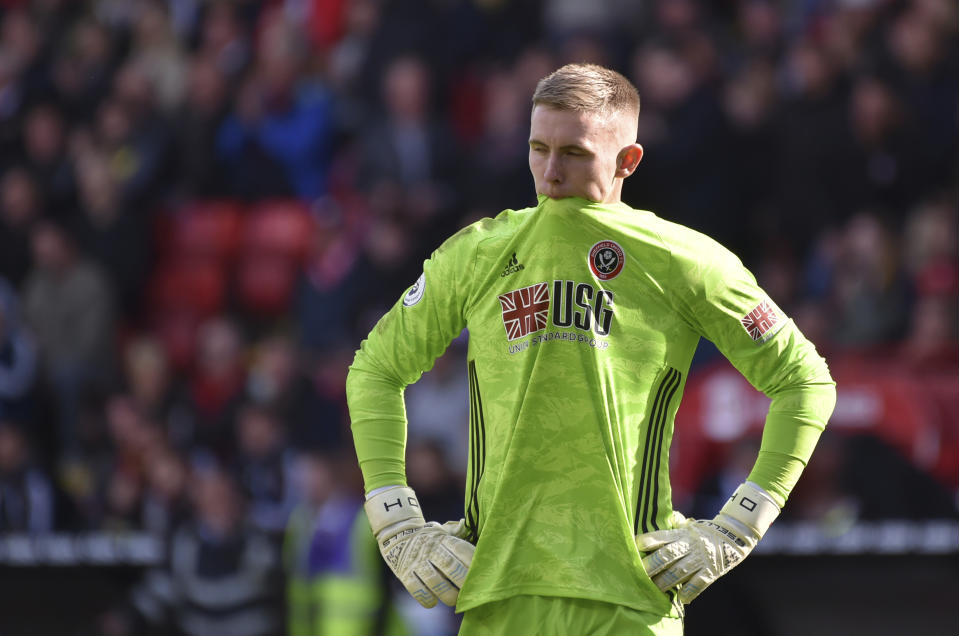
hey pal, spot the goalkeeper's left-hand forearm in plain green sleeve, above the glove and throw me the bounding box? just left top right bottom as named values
left=346, top=364, right=406, bottom=492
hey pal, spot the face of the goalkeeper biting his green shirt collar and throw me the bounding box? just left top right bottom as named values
left=529, top=105, right=642, bottom=203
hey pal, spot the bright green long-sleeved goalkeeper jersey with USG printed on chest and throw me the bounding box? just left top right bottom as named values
left=347, top=197, right=834, bottom=615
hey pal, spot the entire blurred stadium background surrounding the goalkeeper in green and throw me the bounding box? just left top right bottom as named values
left=0, top=0, right=959, bottom=636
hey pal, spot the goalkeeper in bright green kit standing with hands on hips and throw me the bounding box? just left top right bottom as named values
left=347, top=65, right=835, bottom=634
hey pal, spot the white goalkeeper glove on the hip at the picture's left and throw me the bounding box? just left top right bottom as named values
left=365, top=486, right=475, bottom=607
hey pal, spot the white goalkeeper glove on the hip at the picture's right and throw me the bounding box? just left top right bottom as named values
left=636, top=481, right=779, bottom=603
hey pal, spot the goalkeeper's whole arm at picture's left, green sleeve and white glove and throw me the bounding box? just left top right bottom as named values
left=346, top=229, right=473, bottom=607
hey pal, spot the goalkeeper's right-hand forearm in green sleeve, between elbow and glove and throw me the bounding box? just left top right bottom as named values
left=748, top=378, right=836, bottom=507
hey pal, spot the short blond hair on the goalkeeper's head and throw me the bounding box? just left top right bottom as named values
left=533, top=64, right=639, bottom=117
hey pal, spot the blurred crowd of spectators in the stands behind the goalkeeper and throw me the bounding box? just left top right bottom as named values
left=0, top=0, right=959, bottom=633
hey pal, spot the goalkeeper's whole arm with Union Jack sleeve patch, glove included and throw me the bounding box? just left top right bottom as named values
left=637, top=238, right=835, bottom=603
